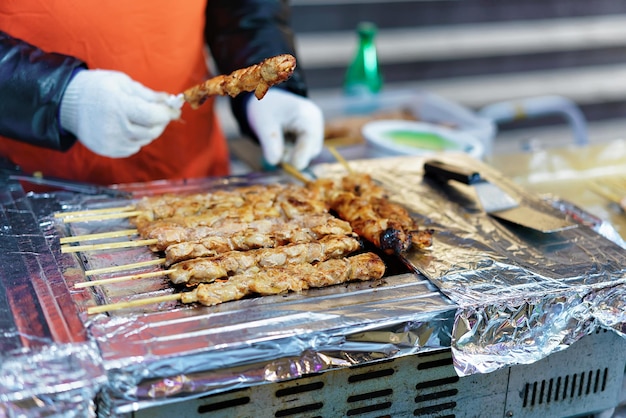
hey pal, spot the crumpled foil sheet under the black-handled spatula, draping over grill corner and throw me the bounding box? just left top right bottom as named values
left=315, top=154, right=626, bottom=376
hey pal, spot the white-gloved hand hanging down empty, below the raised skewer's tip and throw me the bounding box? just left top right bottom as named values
left=246, top=88, right=324, bottom=170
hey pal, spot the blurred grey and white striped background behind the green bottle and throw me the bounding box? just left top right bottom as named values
left=292, top=0, right=626, bottom=154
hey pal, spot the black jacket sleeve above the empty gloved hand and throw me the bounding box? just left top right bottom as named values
left=205, top=0, right=307, bottom=138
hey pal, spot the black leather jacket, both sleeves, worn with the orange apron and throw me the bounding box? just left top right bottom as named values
left=0, top=0, right=306, bottom=151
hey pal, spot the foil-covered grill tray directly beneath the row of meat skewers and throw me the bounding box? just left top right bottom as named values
left=35, top=173, right=454, bottom=416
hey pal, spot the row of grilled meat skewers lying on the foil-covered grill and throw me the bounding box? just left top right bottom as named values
left=57, top=160, right=432, bottom=314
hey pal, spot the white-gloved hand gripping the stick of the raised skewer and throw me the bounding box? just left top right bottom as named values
left=60, top=70, right=183, bottom=158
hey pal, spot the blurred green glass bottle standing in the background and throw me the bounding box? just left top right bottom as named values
left=343, top=22, right=383, bottom=96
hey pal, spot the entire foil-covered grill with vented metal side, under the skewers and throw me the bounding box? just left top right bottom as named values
left=0, top=154, right=626, bottom=417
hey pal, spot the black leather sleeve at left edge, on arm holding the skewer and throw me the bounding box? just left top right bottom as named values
left=0, top=31, right=86, bottom=151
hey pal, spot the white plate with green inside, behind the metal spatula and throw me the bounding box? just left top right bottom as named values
left=362, top=120, right=484, bottom=159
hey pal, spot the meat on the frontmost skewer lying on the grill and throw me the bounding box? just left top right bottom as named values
left=181, top=253, right=385, bottom=306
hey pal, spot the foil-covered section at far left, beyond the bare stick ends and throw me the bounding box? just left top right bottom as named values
left=0, top=182, right=106, bottom=417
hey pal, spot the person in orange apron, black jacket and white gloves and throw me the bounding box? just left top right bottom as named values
left=0, top=0, right=323, bottom=184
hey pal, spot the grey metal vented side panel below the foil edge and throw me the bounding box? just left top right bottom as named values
left=132, top=330, right=626, bottom=418
